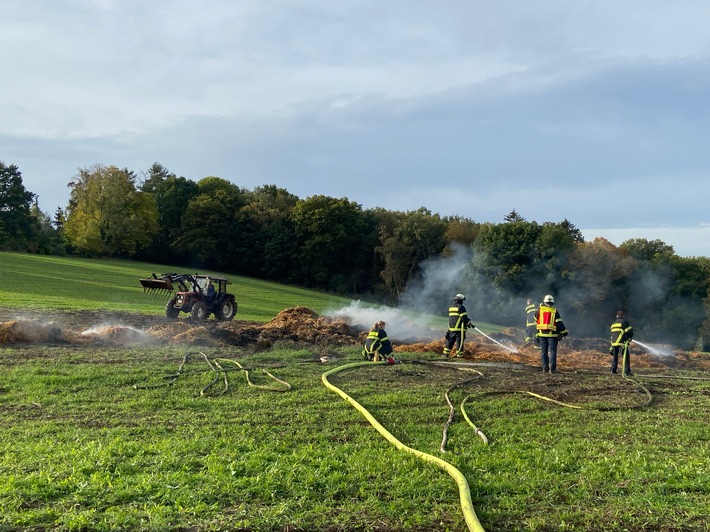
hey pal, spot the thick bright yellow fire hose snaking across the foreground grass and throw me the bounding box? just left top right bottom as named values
left=321, top=362, right=484, bottom=532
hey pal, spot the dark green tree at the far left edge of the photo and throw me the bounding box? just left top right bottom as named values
left=0, top=161, right=36, bottom=251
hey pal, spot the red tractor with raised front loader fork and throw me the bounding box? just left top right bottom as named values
left=140, top=273, right=237, bottom=322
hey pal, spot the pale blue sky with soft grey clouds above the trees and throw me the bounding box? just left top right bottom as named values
left=0, top=0, right=710, bottom=257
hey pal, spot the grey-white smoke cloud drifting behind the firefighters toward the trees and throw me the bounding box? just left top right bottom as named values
left=326, top=239, right=705, bottom=349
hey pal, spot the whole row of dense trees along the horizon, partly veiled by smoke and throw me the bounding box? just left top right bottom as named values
left=0, top=162, right=710, bottom=350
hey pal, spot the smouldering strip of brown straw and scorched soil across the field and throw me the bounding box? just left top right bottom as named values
left=0, top=307, right=710, bottom=371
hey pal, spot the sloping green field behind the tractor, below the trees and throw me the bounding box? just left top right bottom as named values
left=0, top=252, right=350, bottom=321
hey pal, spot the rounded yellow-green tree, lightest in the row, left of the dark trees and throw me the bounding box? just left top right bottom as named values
left=64, top=165, right=158, bottom=257
